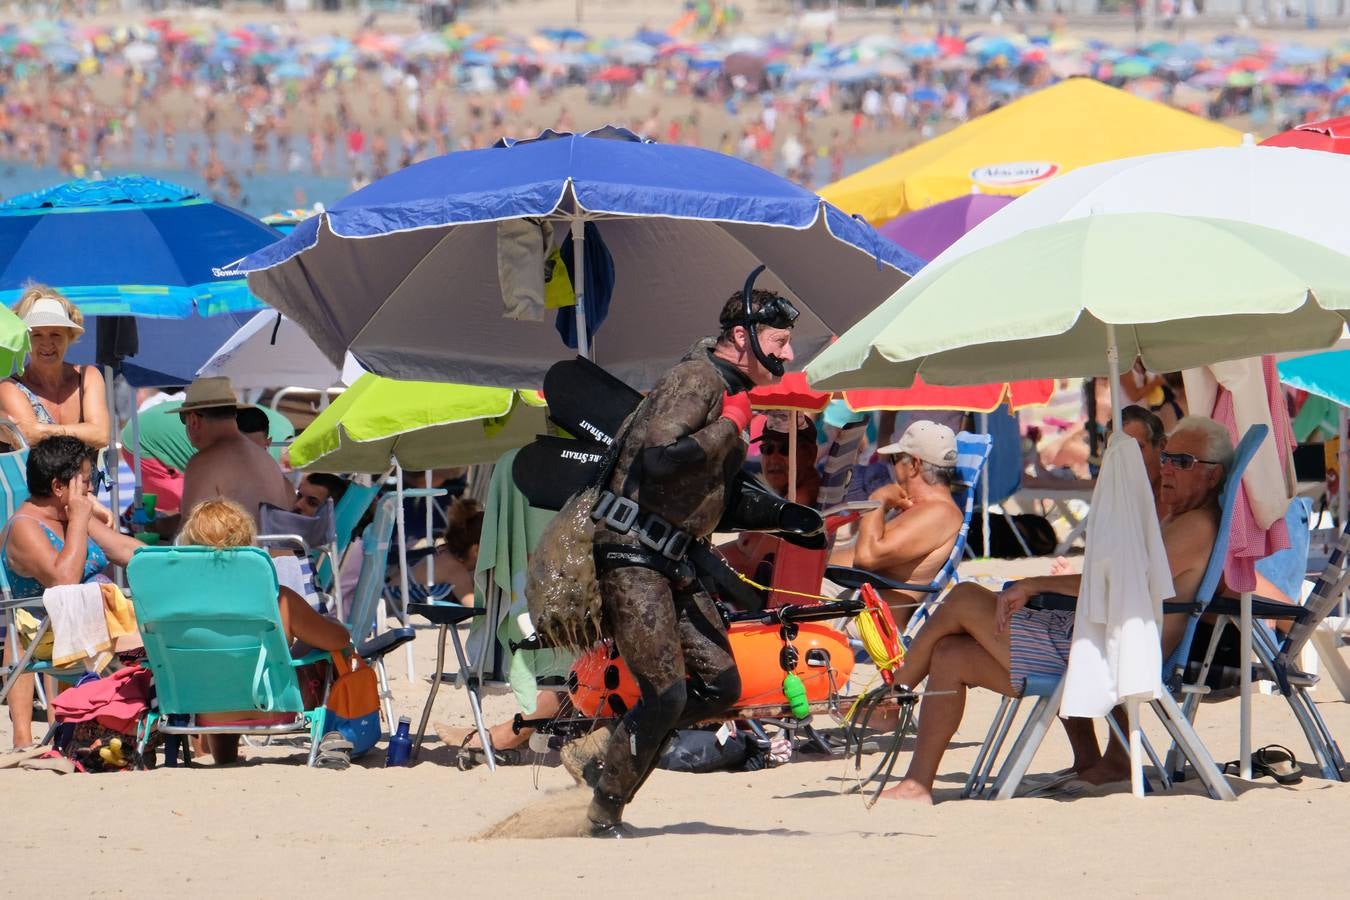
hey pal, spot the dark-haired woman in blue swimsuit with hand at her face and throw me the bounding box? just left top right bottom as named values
left=0, top=436, right=140, bottom=748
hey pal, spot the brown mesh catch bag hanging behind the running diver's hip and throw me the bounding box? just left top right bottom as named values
left=525, top=487, right=601, bottom=652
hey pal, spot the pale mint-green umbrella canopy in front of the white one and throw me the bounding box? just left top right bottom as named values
left=807, top=215, right=1350, bottom=389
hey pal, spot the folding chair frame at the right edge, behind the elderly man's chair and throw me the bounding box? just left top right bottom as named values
left=1168, top=524, right=1350, bottom=781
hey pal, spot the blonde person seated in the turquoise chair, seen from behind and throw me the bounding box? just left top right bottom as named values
left=178, top=499, right=351, bottom=764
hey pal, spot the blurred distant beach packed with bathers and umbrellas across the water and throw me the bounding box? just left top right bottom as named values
left=0, top=0, right=1350, bottom=216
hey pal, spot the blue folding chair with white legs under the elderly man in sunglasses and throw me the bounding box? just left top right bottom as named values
left=961, top=425, right=1269, bottom=800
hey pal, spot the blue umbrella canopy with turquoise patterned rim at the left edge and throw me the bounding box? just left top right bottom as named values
left=0, top=175, right=277, bottom=318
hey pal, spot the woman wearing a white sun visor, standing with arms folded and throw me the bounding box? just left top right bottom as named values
left=0, top=285, right=108, bottom=449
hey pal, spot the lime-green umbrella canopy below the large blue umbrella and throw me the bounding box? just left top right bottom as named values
left=290, top=374, right=545, bottom=472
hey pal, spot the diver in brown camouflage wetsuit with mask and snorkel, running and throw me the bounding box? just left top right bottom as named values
left=564, top=282, right=797, bottom=837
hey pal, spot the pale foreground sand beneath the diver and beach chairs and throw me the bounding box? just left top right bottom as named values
left=0, top=560, right=1350, bottom=897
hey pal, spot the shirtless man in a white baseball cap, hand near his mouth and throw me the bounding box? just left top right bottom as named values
left=853, top=420, right=965, bottom=629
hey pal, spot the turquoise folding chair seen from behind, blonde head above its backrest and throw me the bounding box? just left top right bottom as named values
left=127, top=546, right=328, bottom=765
